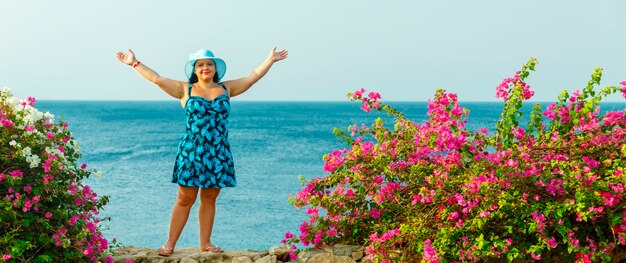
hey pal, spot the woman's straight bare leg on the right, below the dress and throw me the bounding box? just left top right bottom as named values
left=198, top=188, right=221, bottom=249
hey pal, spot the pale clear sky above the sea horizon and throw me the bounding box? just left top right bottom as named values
left=0, top=0, right=626, bottom=101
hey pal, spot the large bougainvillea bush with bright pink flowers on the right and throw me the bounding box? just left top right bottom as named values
left=283, top=59, right=626, bottom=262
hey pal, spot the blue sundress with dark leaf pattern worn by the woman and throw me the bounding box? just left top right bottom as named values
left=172, top=83, right=237, bottom=188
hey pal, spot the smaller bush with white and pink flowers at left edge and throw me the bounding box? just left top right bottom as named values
left=0, top=88, right=112, bottom=262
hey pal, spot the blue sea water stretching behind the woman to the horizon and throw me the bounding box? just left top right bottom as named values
left=36, top=100, right=624, bottom=250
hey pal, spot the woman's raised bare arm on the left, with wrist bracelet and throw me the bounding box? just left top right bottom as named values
left=116, top=49, right=187, bottom=99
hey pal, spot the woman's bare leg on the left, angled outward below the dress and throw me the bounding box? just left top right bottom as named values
left=165, top=186, right=198, bottom=251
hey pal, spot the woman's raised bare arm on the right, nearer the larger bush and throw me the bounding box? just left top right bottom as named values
left=224, top=47, right=289, bottom=97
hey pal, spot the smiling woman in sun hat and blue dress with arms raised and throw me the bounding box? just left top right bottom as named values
left=117, top=47, right=288, bottom=256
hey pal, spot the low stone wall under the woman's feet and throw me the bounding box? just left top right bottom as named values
left=113, top=245, right=371, bottom=263
